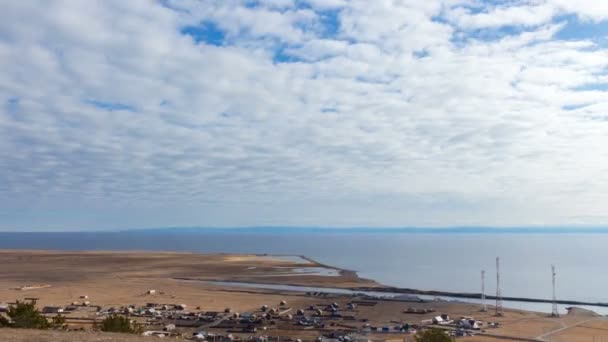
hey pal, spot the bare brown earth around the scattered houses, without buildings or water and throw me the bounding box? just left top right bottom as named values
left=0, top=250, right=608, bottom=342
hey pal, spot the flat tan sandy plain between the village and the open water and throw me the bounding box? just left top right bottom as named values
left=0, top=251, right=377, bottom=311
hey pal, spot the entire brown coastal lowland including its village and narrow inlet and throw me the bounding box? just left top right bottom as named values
left=0, top=250, right=608, bottom=342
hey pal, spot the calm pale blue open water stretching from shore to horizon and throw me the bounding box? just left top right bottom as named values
left=0, top=232, right=608, bottom=302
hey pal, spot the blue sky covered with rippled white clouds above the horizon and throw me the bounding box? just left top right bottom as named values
left=0, top=0, right=608, bottom=231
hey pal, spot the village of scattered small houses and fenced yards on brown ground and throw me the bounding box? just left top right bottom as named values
left=0, top=289, right=498, bottom=342
